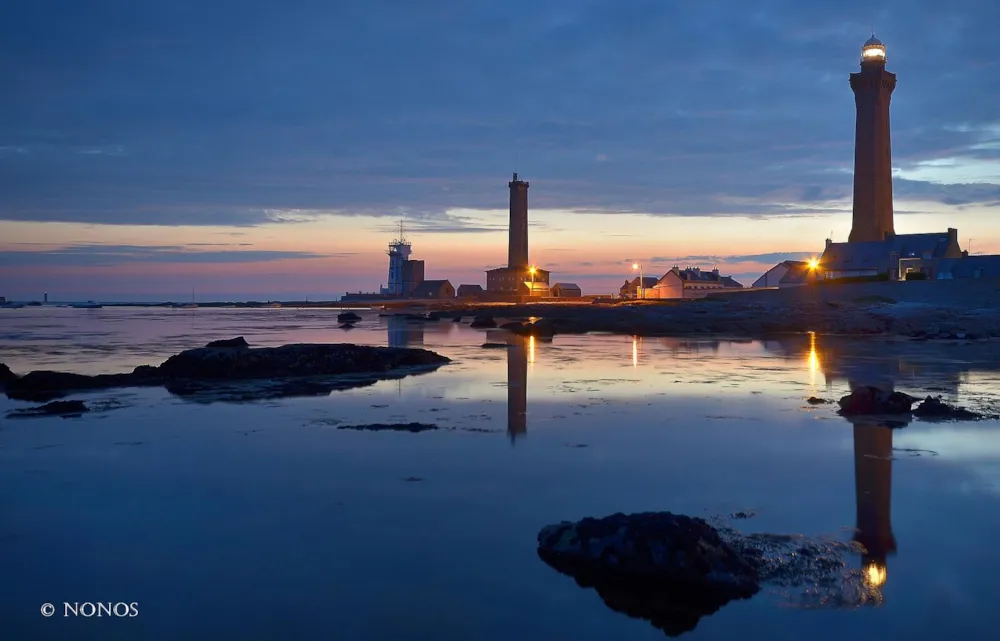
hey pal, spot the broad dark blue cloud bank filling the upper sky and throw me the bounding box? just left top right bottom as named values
left=0, top=0, right=1000, bottom=233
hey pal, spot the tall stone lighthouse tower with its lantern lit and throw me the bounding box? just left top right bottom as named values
left=848, top=34, right=896, bottom=242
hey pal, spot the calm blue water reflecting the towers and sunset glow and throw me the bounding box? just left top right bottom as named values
left=0, top=308, right=1000, bottom=641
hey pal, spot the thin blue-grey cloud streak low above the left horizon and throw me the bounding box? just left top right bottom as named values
left=0, top=244, right=344, bottom=267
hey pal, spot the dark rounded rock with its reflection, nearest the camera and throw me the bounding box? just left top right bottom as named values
left=538, top=512, right=760, bottom=636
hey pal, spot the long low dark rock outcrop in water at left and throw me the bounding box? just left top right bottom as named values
left=5, top=339, right=450, bottom=401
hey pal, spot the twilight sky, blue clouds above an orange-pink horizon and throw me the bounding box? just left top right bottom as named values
left=0, top=0, right=1000, bottom=301
